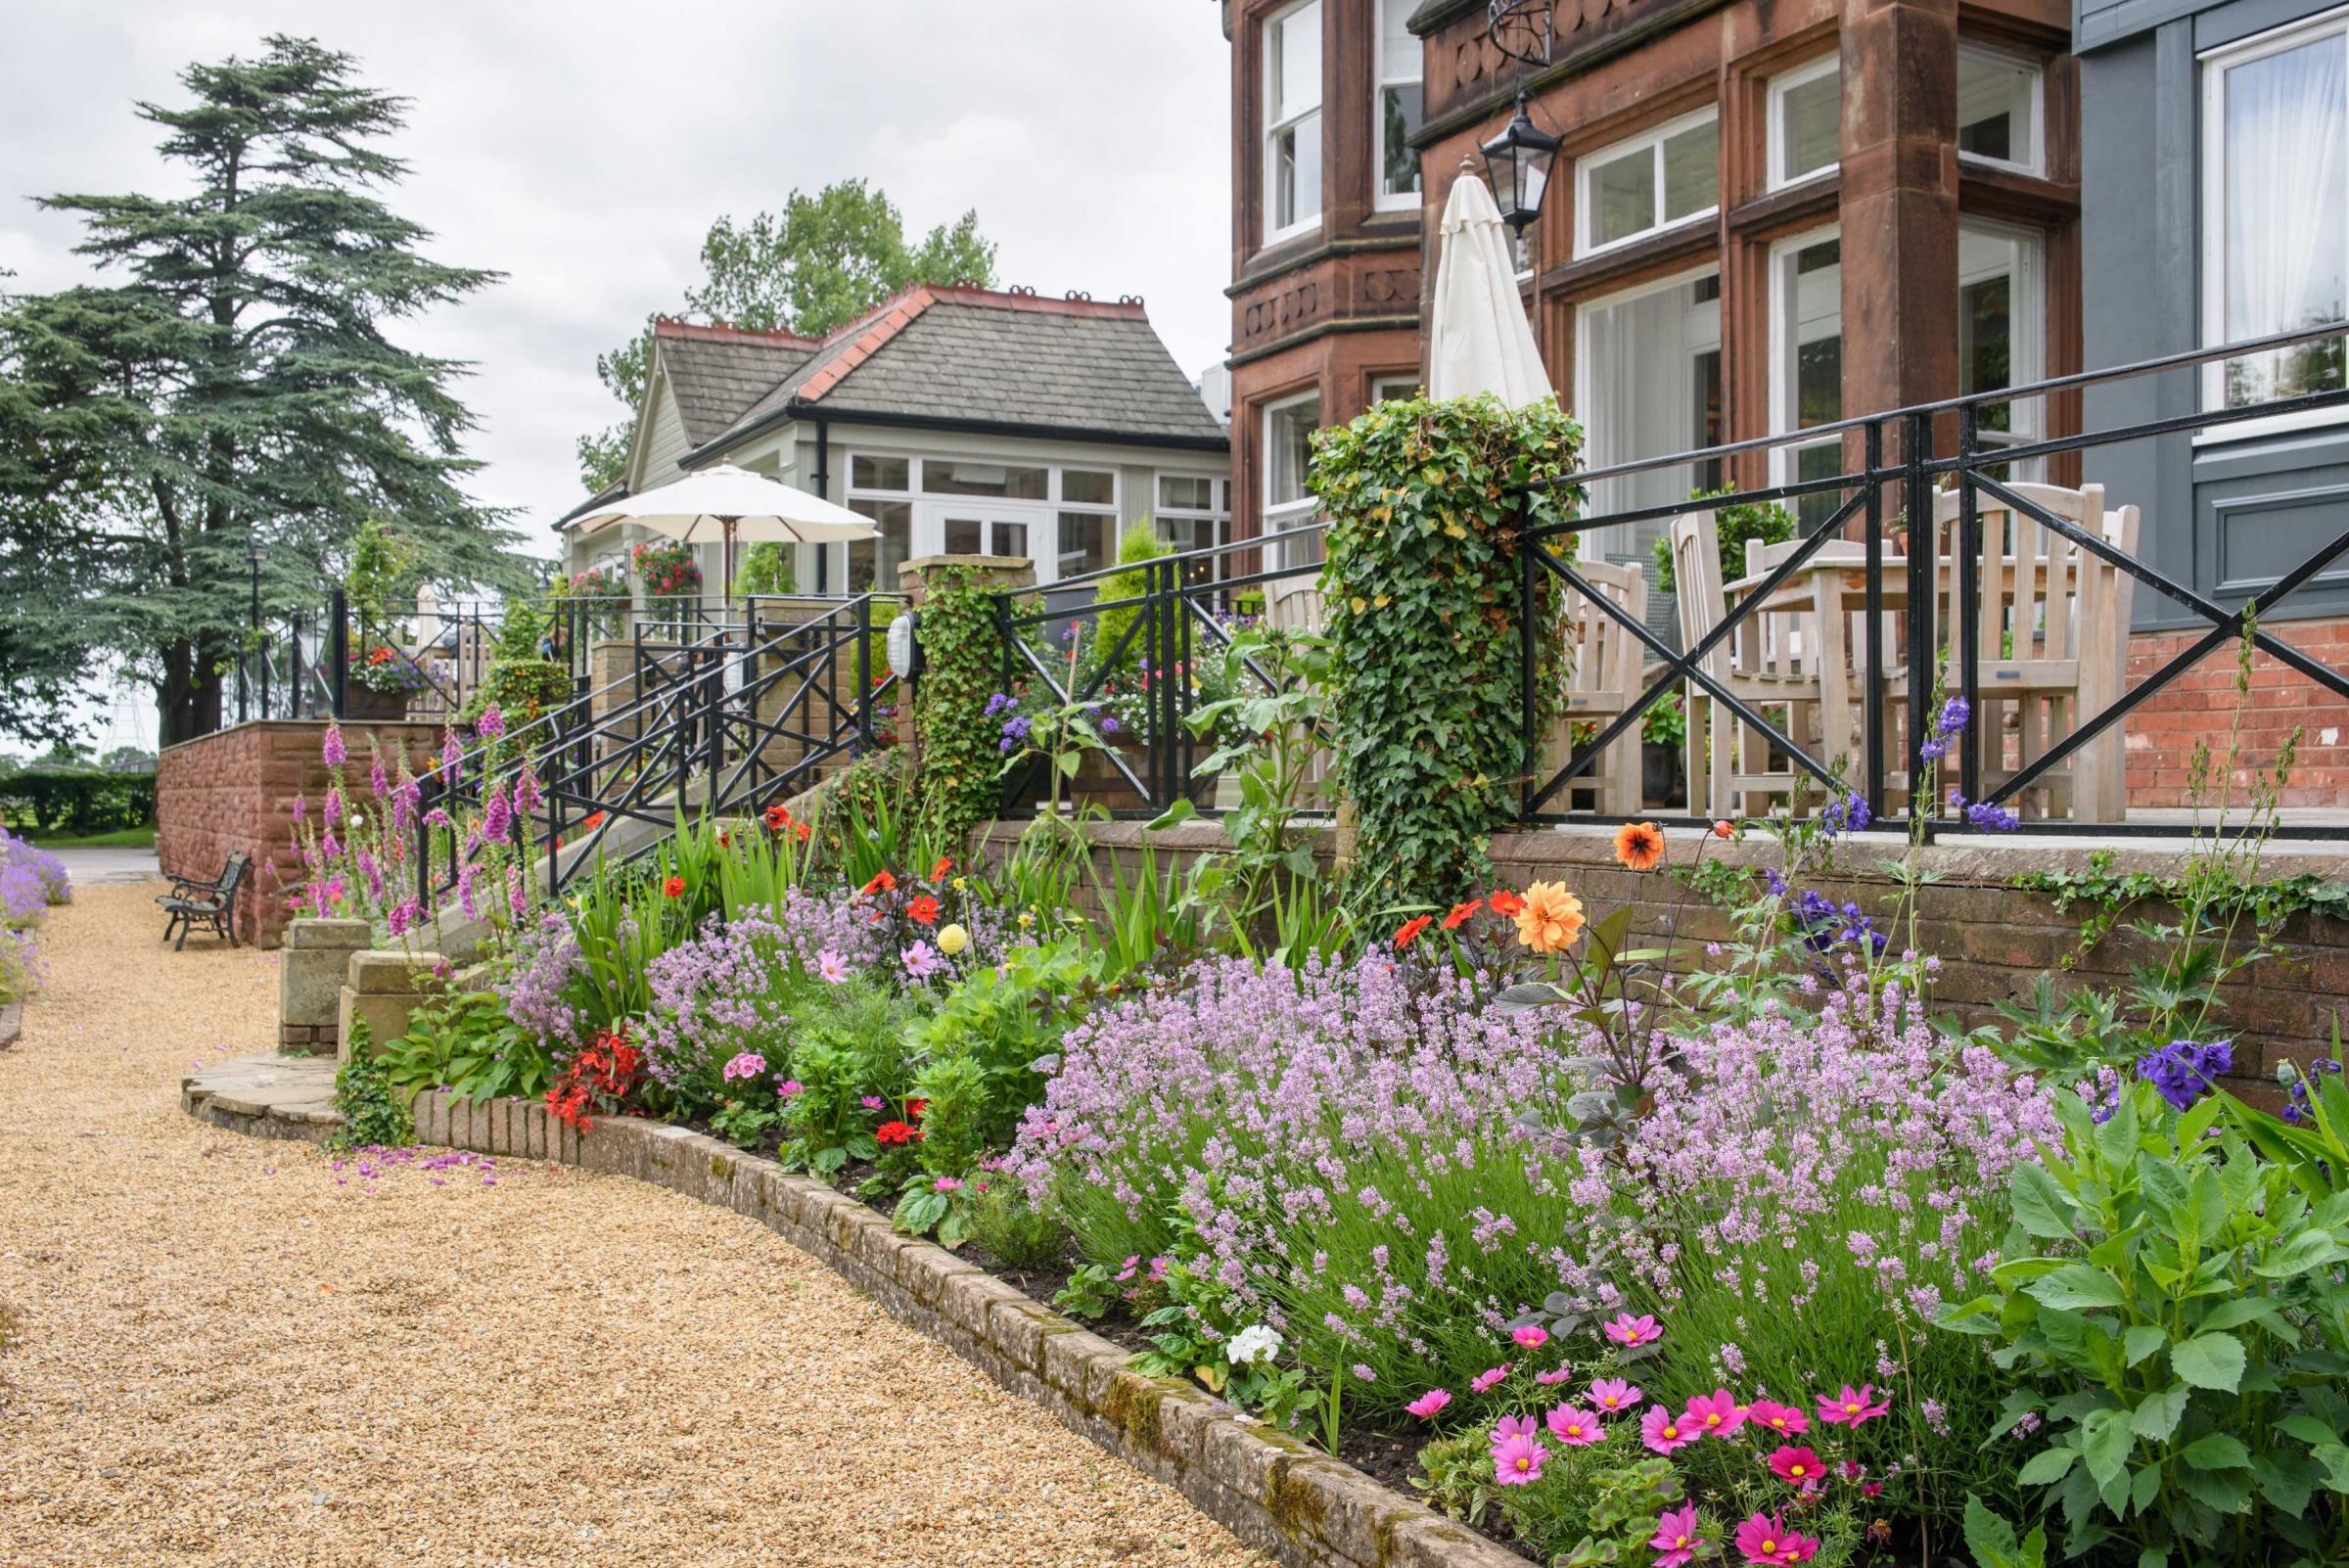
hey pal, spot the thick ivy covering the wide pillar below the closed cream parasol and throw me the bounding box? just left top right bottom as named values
left=1311, top=396, right=1584, bottom=903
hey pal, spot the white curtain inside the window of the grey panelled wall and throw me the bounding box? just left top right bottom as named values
left=2225, top=33, right=2349, bottom=406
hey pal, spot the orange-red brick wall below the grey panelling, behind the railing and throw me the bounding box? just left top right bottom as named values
left=2128, top=620, right=2349, bottom=807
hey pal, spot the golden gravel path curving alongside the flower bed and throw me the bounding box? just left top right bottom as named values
left=0, top=885, right=1264, bottom=1568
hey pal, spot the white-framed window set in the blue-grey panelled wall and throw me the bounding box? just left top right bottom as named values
left=2201, top=12, right=2349, bottom=437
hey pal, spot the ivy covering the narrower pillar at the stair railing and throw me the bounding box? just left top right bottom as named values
left=914, top=568, right=1003, bottom=845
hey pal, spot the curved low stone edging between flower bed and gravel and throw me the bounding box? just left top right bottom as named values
left=401, top=1091, right=1525, bottom=1568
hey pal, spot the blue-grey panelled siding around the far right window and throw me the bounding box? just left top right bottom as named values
left=2077, top=0, right=2349, bottom=631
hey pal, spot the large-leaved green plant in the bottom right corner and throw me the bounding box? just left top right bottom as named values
left=1940, top=1084, right=2349, bottom=1568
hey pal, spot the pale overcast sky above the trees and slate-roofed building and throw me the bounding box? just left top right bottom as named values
left=0, top=0, right=1231, bottom=563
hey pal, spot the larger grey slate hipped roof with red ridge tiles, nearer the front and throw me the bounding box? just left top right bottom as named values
left=698, top=287, right=1226, bottom=460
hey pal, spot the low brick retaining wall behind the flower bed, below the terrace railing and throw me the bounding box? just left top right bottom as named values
left=977, top=821, right=2349, bottom=1106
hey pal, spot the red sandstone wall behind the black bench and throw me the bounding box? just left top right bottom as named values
left=155, top=718, right=439, bottom=945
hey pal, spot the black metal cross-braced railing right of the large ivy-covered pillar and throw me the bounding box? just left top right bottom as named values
left=1520, top=311, right=2349, bottom=836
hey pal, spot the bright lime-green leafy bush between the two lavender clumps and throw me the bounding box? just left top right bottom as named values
left=906, top=937, right=1102, bottom=1176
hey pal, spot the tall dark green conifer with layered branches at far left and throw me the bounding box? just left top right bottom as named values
left=0, top=35, right=522, bottom=744
